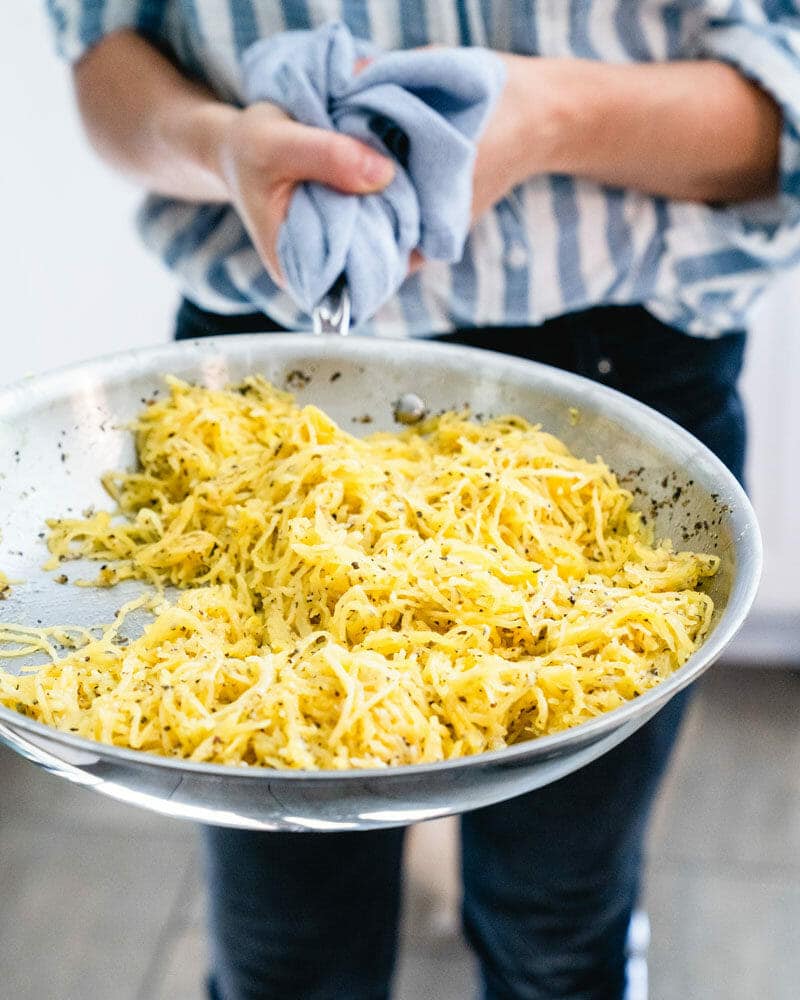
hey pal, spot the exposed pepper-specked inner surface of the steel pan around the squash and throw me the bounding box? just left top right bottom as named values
left=0, top=335, right=758, bottom=744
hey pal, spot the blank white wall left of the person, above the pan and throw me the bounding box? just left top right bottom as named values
left=0, top=6, right=175, bottom=382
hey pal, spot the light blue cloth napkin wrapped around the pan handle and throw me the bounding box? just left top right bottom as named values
left=243, top=23, right=505, bottom=326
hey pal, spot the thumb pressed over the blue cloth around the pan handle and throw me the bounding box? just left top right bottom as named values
left=284, top=125, right=395, bottom=194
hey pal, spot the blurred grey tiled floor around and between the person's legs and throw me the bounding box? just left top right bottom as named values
left=0, top=668, right=800, bottom=1000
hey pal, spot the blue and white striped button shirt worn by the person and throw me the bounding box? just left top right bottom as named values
left=47, top=0, right=800, bottom=336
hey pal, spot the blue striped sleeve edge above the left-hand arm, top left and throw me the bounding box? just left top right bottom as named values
left=46, top=0, right=168, bottom=62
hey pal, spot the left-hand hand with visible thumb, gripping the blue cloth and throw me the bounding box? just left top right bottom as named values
left=217, top=103, right=394, bottom=286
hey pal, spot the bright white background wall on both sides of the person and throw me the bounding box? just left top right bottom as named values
left=0, top=0, right=800, bottom=655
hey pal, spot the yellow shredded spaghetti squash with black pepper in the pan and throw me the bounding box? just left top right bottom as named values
left=0, top=377, right=718, bottom=769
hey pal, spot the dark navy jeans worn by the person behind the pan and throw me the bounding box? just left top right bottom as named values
left=178, top=298, right=745, bottom=1000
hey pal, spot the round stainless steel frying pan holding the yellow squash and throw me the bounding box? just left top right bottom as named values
left=0, top=334, right=761, bottom=830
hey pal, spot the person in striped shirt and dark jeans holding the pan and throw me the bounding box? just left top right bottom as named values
left=48, top=0, right=800, bottom=1000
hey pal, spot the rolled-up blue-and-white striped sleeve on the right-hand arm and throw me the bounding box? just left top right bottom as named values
left=697, top=0, right=800, bottom=265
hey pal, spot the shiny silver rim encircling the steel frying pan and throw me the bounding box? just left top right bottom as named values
left=0, top=333, right=763, bottom=783
